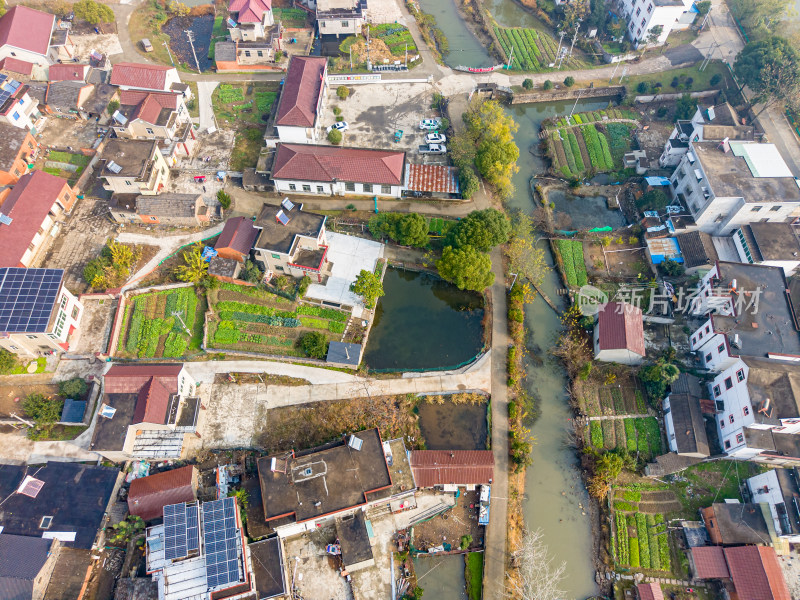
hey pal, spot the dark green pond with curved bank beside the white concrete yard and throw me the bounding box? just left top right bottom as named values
left=364, top=268, right=483, bottom=370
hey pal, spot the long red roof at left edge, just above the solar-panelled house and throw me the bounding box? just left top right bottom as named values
left=0, top=171, right=69, bottom=267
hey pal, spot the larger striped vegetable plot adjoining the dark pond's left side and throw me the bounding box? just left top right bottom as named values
left=207, top=283, right=349, bottom=356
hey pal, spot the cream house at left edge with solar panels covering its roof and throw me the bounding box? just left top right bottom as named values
left=0, top=268, right=83, bottom=358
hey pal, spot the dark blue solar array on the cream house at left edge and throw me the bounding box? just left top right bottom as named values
left=0, top=267, right=64, bottom=333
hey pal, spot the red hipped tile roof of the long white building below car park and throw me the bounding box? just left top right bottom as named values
left=272, top=144, right=405, bottom=185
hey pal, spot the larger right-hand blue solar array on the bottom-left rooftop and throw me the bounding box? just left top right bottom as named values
left=203, top=498, right=239, bottom=588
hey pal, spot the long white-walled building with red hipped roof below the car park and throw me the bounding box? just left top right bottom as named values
left=272, top=144, right=405, bottom=198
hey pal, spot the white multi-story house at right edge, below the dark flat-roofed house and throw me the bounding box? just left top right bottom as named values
left=708, top=358, right=800, bottom=464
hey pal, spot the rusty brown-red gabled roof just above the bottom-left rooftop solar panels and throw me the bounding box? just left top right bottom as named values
left=128, top=465, right=195, bottom=521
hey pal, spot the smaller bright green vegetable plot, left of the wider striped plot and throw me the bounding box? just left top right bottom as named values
left=117, top=287, right=204, bottom=358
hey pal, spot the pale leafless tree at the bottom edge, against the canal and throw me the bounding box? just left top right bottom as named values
left=508, top=529, right=567, bottom=600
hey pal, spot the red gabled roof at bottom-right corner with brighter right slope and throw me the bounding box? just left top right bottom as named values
left=725, top=546, right=790, bottom=600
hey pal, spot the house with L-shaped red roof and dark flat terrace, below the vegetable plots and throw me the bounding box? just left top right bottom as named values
left=90, top=363, right=200, bottom=462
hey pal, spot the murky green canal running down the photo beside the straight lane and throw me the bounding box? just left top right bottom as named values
left=507, top=100, right=608, bottom=599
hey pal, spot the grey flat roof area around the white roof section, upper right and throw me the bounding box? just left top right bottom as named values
left=690, top=142, right=800, bottom=204
